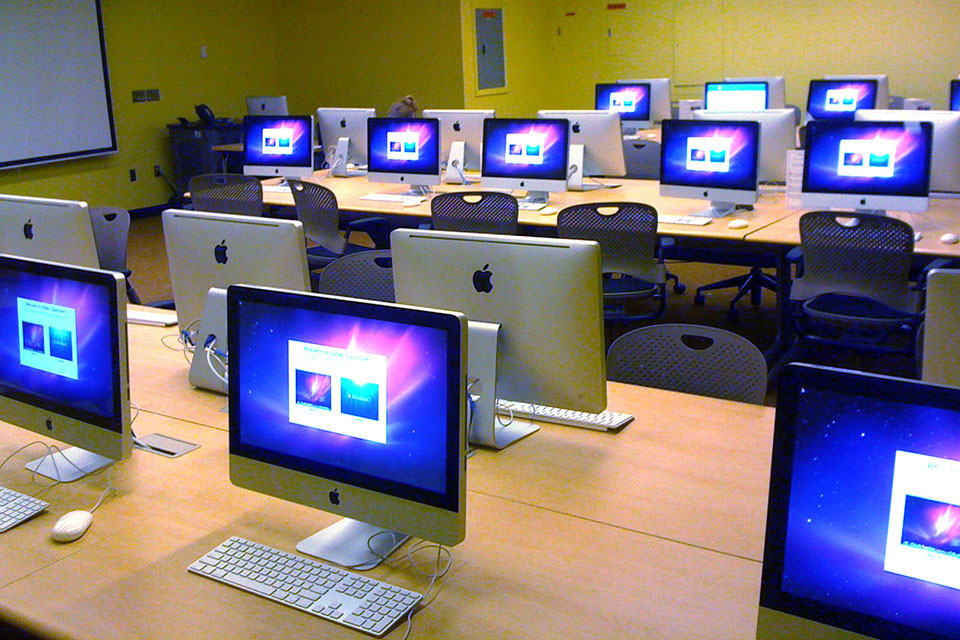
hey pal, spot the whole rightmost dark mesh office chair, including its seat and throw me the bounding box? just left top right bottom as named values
left=788, top=211, right=922, bottom=368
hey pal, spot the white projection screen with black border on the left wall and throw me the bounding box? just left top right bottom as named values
left=0, top=0, right=117, bottom=169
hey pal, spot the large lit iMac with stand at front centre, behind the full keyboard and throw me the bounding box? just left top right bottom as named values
left=227, top=286, right=467, bottom=568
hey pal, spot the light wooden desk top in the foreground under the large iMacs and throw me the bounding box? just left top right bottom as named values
left=0, top=326, right=773, bottom=640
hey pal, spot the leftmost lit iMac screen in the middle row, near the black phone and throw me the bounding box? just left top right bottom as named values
left=243, top=116, right=313, bottom=178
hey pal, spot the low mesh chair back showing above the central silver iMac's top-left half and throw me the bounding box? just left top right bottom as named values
left=430, top=191, right=520, bottom=235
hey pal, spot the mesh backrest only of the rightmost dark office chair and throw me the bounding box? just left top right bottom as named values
left=791, top=211, right=917, bottom=312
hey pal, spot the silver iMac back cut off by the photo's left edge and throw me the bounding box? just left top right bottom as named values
left=0, top=195, right=100, bottom=269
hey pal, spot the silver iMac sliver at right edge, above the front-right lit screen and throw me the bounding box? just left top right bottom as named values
left=923, top=269, right=960, bottom=387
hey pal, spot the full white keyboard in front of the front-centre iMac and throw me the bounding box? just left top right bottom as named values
left=188, top=537, right=423, bottom=637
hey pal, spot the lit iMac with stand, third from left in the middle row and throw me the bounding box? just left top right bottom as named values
left=480, top=118, right=570, bottom=208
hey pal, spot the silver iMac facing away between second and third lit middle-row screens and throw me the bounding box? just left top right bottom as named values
left=423, top=109, right=496, bottom=184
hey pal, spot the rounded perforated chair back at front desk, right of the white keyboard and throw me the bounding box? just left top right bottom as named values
left=607, top=324, right=767, bottom=404
